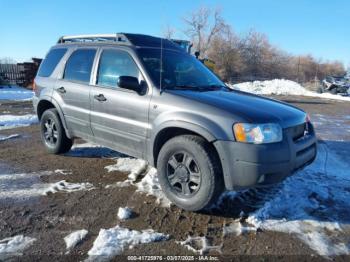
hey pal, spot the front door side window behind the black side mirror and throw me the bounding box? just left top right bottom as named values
left=96, top=49, right=142, bottom=88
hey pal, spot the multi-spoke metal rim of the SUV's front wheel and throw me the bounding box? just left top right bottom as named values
left=167, top=152, right=201, bottom=197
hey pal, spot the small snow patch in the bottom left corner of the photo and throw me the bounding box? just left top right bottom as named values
left=0, top=235, right=36, bottom=260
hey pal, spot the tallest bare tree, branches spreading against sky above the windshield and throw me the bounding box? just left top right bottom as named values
left=184, top=7, right=227, bottom=57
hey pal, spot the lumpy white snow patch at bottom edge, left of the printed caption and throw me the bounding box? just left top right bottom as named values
left=88, top=226, right=169, bottom=261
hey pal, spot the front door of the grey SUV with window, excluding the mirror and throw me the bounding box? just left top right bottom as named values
left=91, top=48, right=151, bottom=157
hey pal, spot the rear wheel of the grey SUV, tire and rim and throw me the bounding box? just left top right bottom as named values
left=40, top=108, right=73, bottom=154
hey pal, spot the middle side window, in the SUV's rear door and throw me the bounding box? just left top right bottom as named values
left=63, top=49, right=96, bottom=84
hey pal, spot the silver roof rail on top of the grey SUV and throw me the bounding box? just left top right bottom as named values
left=57, top=33, right=131, bottom=44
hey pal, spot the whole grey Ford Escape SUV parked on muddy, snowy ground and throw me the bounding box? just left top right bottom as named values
left=33, top=33, right=317, bottom=210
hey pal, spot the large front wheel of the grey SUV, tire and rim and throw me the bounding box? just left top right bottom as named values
left=157, top=135, right=224, bottom=211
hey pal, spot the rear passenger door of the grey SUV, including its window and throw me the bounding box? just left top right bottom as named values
left=54, top=48, right=97, bottom=138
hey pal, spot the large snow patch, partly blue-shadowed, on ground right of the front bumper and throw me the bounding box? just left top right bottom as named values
left=234, top=143, right=350, bottom=256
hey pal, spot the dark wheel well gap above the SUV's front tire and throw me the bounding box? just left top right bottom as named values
left=153, top=127, right=217, bottom=167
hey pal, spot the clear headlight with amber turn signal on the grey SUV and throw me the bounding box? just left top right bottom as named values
left=233, top=123, right=282, bottom=144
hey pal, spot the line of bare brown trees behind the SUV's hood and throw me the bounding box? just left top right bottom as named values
left=171, top=7, right=346, bottom=83
